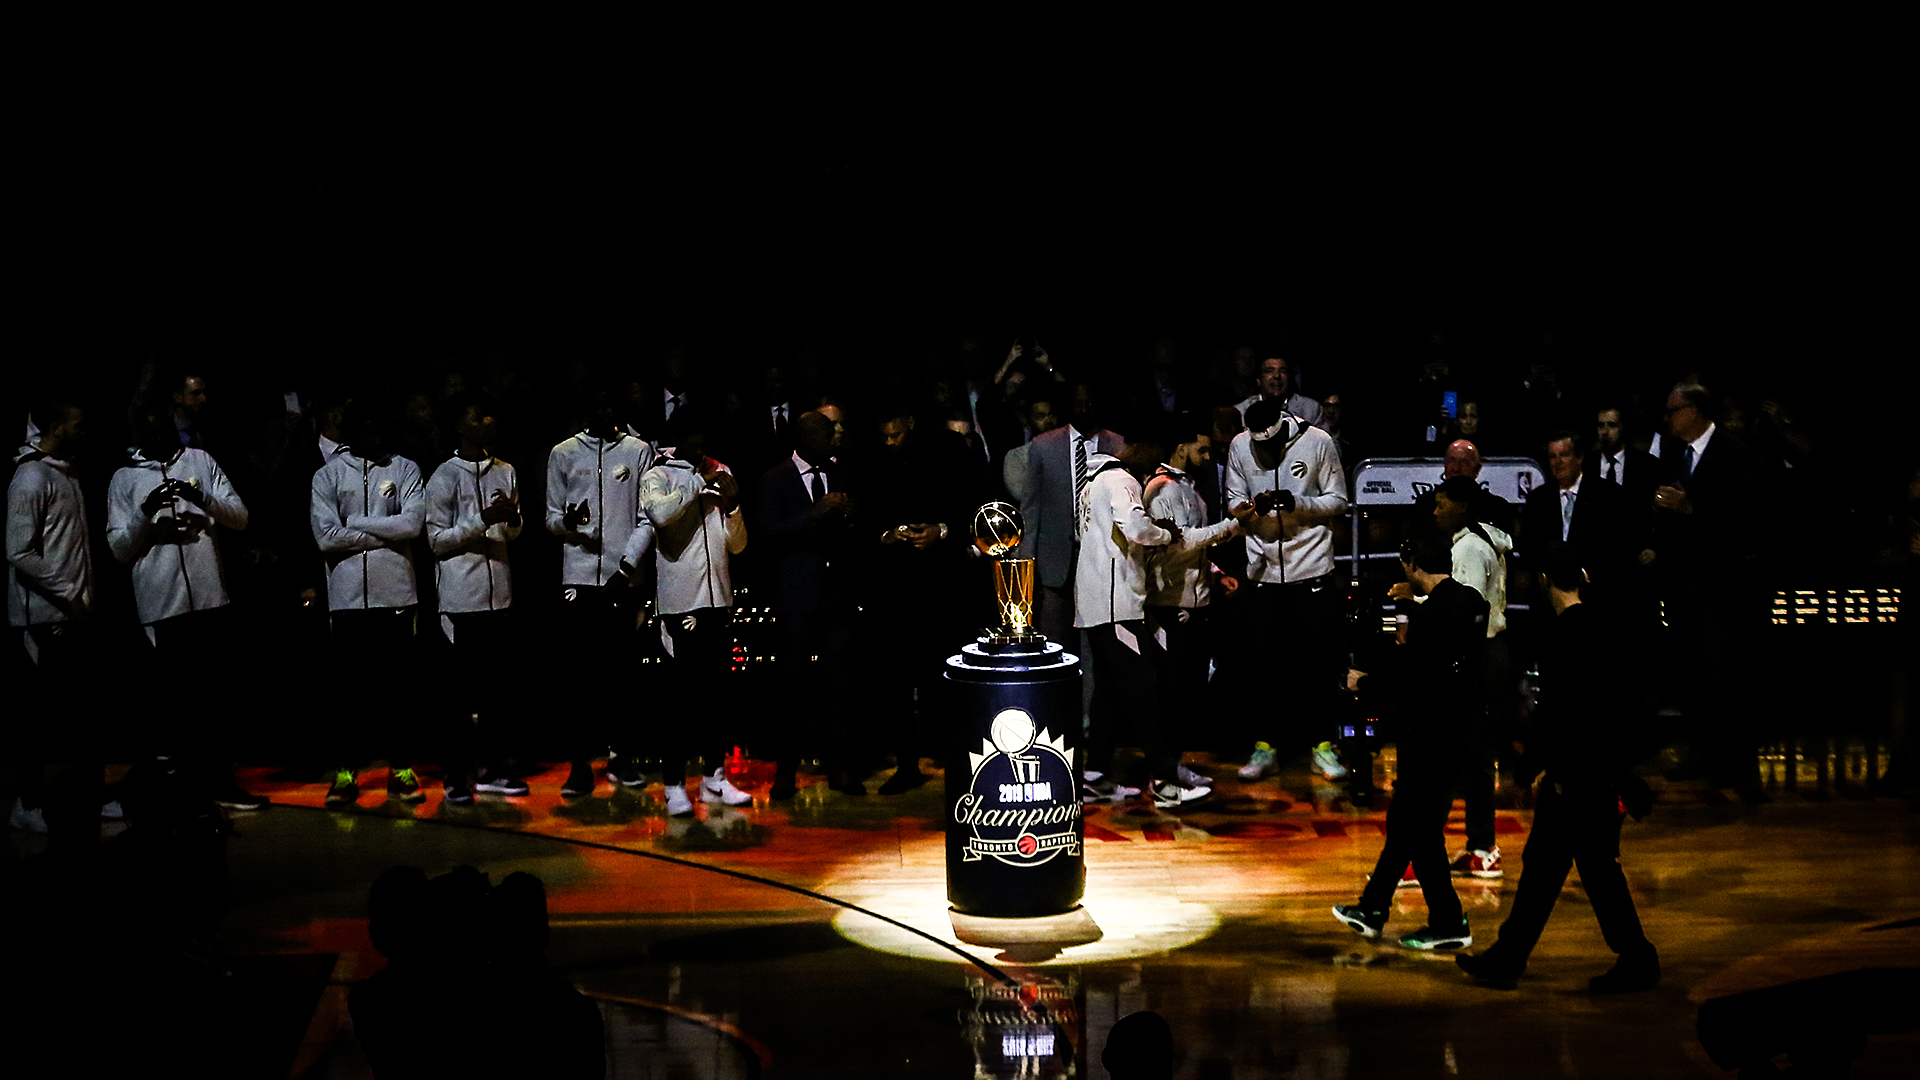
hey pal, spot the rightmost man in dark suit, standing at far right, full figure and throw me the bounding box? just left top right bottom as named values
left=1653, top=382, right=1766, bottom=788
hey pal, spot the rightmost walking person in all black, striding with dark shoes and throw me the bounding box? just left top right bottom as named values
left=1457, top=544, right=1661, bottom=994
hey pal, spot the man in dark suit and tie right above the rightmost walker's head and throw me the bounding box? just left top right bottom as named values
left=1521, top=430, right=1638, bottom=615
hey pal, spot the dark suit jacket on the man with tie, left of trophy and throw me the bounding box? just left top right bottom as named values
left=753, top=455, right=854, bottom=613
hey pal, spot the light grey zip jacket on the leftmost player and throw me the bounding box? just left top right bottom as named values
left=6, top=446, right=94, bottom=626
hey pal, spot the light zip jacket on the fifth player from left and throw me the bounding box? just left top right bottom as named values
left=547, top=432, right=655, bottom=584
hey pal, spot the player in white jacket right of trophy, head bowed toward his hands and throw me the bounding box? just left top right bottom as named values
left=1227, top=398, right=1348, bottom=780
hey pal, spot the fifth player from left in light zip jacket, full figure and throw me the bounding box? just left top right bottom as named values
left=547, top=390, right=655, bottom=796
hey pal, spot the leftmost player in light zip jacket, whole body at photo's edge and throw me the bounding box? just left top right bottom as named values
left=6, top=398, right=104, bottom=840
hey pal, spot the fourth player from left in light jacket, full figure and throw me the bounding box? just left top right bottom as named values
left=426, top=400, right=528, bottom=805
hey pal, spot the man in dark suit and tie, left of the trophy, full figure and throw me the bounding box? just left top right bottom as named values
left=755, top=413, right=866, bottom=799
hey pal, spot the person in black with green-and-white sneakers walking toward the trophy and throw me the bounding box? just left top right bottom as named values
left=1332, top=540, right=1486, bottom=949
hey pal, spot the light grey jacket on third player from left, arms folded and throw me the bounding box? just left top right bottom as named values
left=307, top=450, right=426, bottom=611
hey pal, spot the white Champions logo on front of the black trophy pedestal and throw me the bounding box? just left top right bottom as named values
left=954, top=709, right=1081, bottom=867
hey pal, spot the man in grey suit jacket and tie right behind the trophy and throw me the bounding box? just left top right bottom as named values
left=1020, top=382, right=1127, bottom=648
